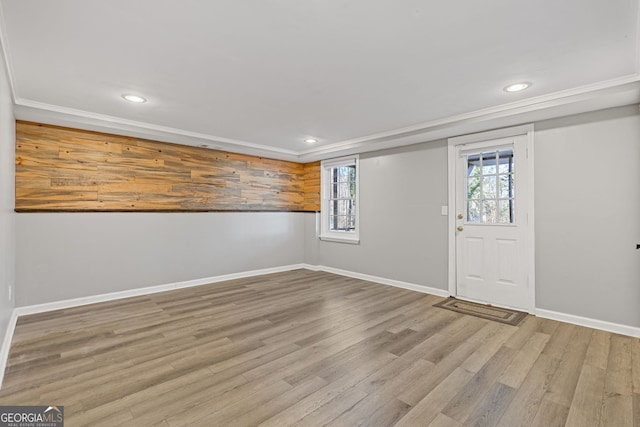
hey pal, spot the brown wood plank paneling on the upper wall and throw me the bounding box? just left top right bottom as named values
left=16, top=121, right=320, bottom=212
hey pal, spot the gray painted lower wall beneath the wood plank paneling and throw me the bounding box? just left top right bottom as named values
left=16, top=212, right=304, bottom=306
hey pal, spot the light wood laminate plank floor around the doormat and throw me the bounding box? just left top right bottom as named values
left=0, top=270, right=640, bottom=427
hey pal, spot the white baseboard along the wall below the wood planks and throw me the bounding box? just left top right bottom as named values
left=16, top=264, right=306, bottom=316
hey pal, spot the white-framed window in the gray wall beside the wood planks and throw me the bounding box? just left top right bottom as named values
left=320, top=156, right=359, bottom=243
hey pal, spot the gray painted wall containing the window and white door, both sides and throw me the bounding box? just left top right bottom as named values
left=305, top=106, right=640, bottom=326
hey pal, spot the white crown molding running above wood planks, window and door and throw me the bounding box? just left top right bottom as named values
left=14, top=74, right=640, bottom=163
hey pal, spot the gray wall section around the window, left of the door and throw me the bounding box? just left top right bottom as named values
left=305, top=141, right=448, bottom=289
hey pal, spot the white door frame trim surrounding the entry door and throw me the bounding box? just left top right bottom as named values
left=447, top=124, right=536, bottom=314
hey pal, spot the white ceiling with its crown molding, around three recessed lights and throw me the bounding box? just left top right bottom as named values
left=0, top=0, right=640, bottom=161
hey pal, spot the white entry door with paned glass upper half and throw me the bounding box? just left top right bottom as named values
left=453, top=134, right=533, bottom=311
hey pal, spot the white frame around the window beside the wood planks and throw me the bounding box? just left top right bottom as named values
left=320, top=155, right=360, bottom=244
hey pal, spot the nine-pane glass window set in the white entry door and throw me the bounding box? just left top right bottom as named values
left=466, top=148, right=515, bottom=224
